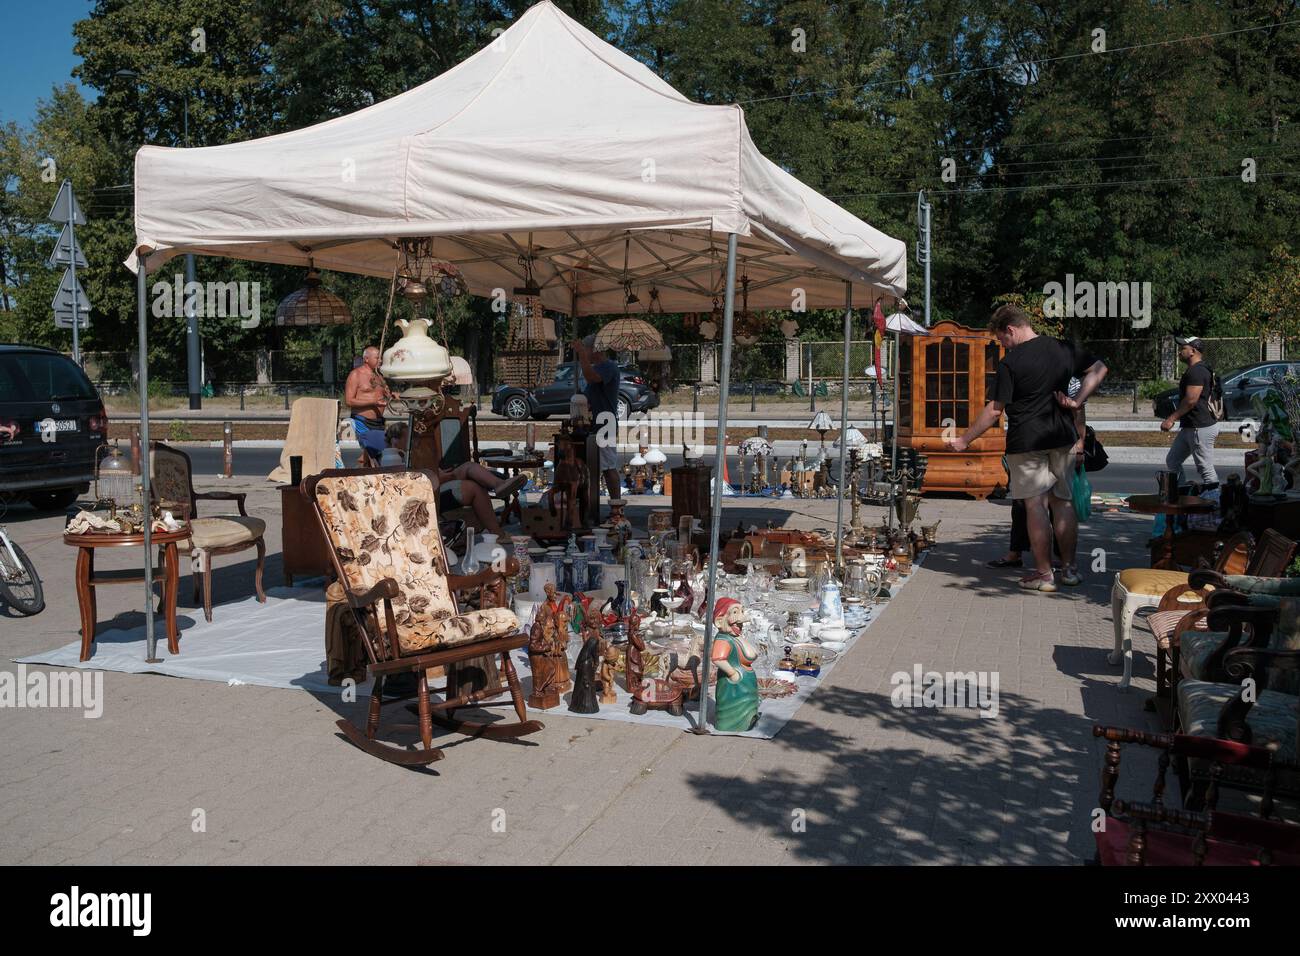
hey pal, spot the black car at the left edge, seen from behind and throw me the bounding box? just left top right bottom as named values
left=0, top=343, right=108, bottom=510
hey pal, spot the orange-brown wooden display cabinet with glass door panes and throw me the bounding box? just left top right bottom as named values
left=896, top=323, right=1006, bottom=498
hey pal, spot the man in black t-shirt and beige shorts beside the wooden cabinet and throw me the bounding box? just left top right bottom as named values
left=948, top=304, right=1106, bottom=591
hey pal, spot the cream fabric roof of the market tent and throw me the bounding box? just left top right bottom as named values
left=135, top=0, right=907, bottom=315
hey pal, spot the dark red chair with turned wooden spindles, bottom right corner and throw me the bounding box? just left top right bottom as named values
left=1092, top=724, right=1300, bottom=866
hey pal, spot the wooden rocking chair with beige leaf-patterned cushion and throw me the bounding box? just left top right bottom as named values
left=304, top=468, right=542, bottom=766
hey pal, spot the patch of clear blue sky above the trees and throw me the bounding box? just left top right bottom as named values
left=0, top=0, right=94, bottom=125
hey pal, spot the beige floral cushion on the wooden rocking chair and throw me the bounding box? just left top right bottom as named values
left=316, top=471, right=519, bottom=656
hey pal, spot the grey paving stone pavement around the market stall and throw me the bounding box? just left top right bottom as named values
left=0, top=479, right=1156, bottom=865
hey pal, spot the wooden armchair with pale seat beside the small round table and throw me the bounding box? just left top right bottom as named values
left=150, top=441, right=267, bottom=620
